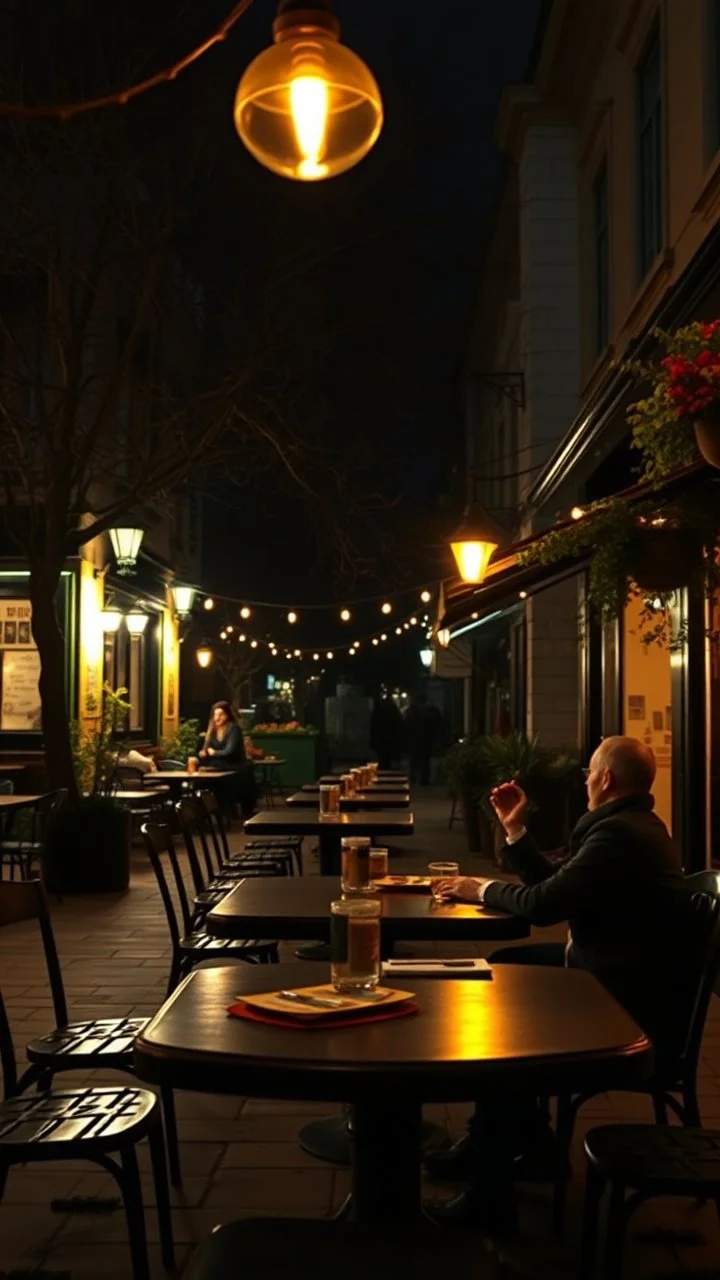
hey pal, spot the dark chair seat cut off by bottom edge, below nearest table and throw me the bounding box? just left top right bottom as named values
left=183, top=1217, right=491, bottom=1280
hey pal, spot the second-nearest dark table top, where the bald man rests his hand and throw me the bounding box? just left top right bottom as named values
left=206, top=876, right=530, bottom=942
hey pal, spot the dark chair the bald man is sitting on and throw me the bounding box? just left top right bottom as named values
left=553, top=893, right=720, bottom=1234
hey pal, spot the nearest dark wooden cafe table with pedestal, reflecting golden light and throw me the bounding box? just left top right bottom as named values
left=133, top=963, right=652, bottom=1222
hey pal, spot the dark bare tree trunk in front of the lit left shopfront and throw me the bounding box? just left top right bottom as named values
left=29, top=561, right=78, bottom=800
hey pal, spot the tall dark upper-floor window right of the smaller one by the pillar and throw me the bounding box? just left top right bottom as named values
left=635, top=26, right=664, bottom=279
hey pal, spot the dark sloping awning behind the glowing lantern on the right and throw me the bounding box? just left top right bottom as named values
left=437, top=462, right=708, bottom=630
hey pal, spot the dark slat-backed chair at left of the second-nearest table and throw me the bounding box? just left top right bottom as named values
left=142, top=823, right=278, bottom=996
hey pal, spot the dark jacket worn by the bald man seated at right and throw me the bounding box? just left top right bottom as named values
left=484, top=796, right=692, bottom=1054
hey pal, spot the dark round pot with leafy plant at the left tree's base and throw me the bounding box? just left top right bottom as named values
left=45, top=685, right=132, bottom=893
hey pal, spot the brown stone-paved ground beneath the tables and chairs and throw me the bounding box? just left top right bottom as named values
left=0, top=788, right=720, bottom=1280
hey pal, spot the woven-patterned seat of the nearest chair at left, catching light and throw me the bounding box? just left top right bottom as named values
left=0, top=1088, right=158, bottom=1164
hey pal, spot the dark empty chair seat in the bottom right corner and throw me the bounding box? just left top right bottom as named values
left=585, top=1124, right=720, bottom=1196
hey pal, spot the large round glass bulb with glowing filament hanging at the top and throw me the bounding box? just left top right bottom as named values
left=234, top=0, right=383, bottom=182
